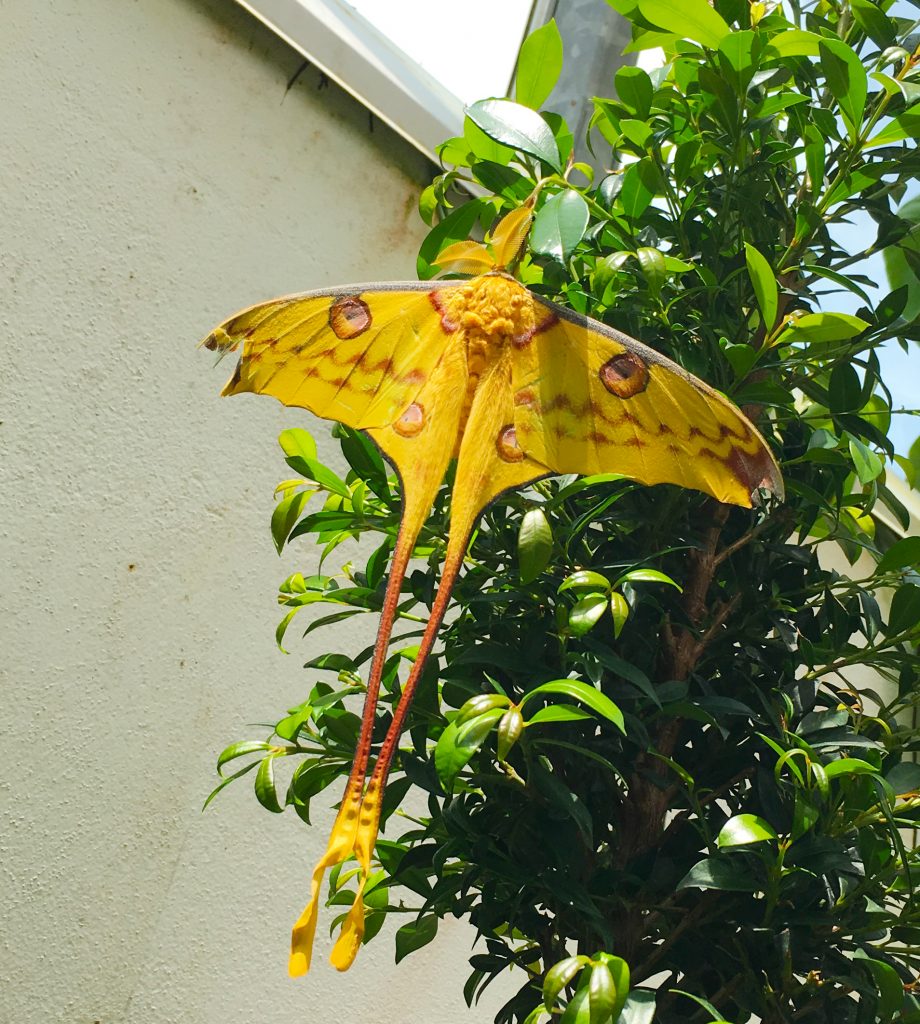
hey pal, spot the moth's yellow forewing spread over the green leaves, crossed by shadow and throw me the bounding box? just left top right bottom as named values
left=513, top=296, right=783, bottom=507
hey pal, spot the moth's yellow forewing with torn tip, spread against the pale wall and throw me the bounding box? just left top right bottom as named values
left=204, top=282, right=460, bottom=429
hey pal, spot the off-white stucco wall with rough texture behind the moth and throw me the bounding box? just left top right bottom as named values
left=0, top=0, right=508, bottom=1024
